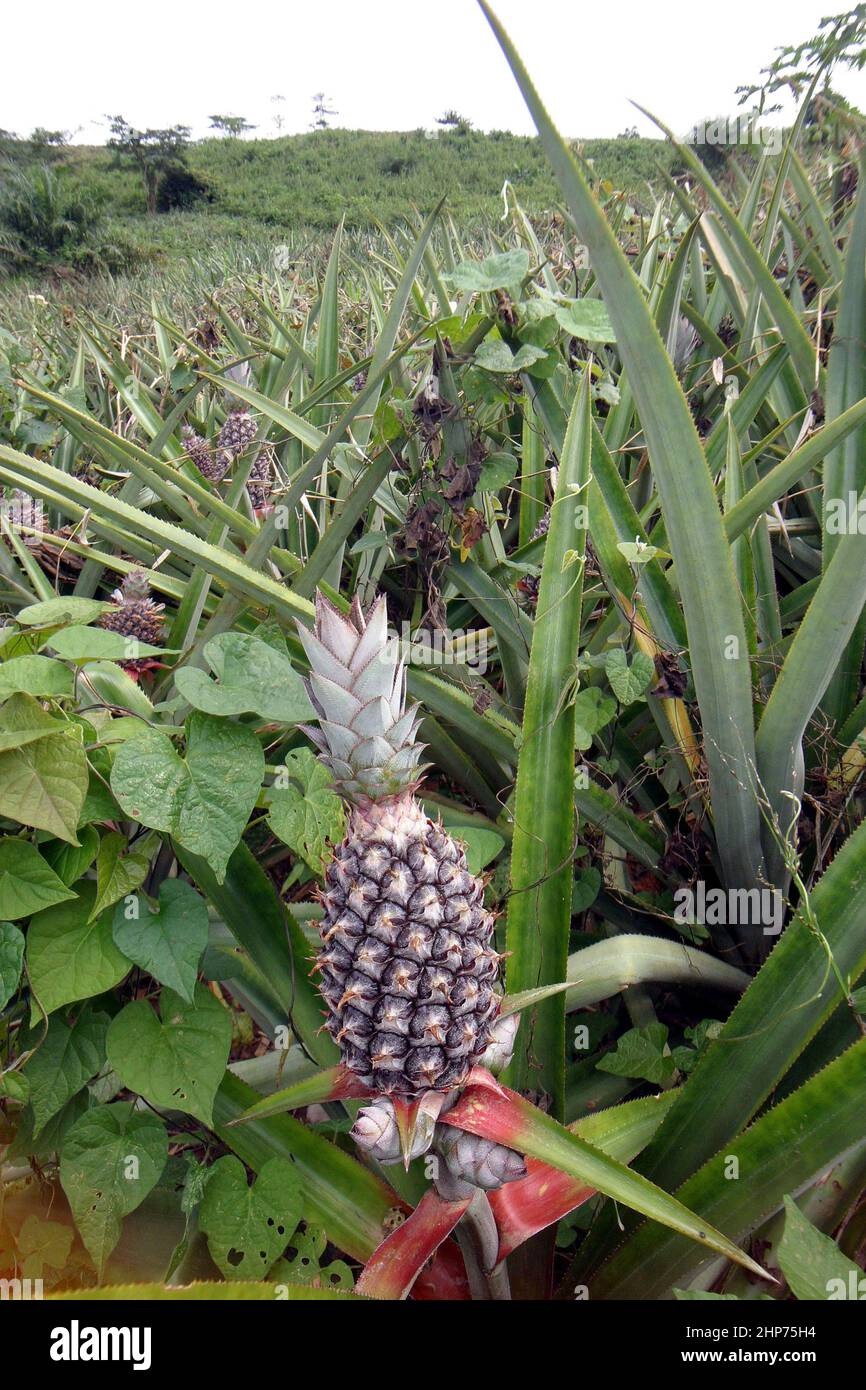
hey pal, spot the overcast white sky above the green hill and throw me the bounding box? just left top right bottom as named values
left=0, top=0, right=866, bottom=143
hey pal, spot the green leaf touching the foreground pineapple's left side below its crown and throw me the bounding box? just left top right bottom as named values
left=268, top=748, right=345, bottom=874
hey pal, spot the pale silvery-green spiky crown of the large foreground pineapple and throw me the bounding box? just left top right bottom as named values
left=297, top=592, right=424, bottom=803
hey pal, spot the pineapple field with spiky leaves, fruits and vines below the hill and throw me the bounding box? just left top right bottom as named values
left=0, top=0, right=866, bottom=1319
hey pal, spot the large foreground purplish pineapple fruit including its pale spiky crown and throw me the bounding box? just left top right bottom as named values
left=299, top=594, right=499, bottom=1098
